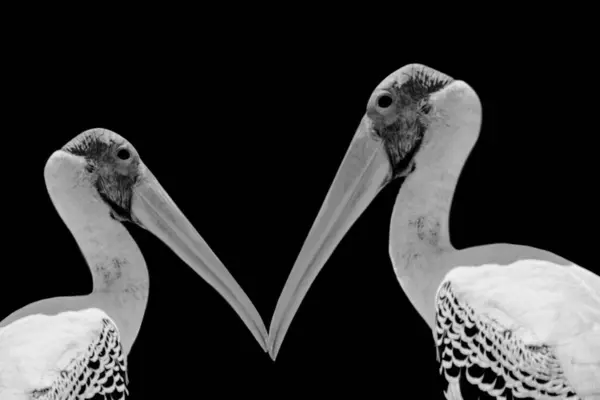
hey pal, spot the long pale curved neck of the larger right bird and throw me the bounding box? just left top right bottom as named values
left=389, top=85, right=481, bottom=328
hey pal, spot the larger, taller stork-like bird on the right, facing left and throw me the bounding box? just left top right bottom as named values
left=268, top=64, right=600, bottom=400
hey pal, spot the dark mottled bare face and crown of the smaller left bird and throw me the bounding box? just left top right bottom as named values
left=62, top=128, right=142, bottom=222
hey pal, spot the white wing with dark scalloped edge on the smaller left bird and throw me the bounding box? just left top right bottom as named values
left=0, top=309, right=127, bottom=400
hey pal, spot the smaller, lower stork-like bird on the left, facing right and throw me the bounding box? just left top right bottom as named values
left=0, top=128, right=267, bottom=400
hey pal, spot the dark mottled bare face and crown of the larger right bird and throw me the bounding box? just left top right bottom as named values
left=367, top=64, right=453, bottom=179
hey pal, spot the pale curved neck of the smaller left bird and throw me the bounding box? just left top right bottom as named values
left=48, top=159, right=149, bottom=351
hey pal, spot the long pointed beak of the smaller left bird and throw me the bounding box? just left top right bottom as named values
left=132, top=166, right=267, bottom=351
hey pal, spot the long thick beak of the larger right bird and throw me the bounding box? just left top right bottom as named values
left=269, top=116, right=391, bottom=360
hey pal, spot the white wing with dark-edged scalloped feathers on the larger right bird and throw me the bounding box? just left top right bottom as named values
left=436, top=260, right=600, bottom=399
